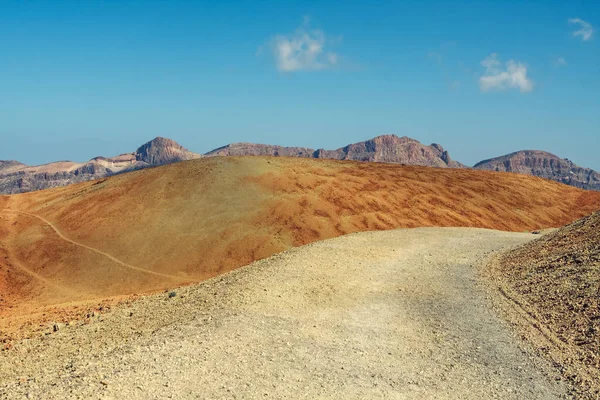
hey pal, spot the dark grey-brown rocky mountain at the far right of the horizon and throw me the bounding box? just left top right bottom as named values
left=473, top=150, right=600, bottom=190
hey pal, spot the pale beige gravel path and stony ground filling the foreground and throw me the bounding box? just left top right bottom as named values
left=0, top=228, right=565, bottom=400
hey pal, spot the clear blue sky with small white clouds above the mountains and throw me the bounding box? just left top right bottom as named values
left=0, top=0, right=600, bottom=170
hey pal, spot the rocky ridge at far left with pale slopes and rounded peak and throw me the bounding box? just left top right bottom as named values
left=0, top=138, right=201, bottom=194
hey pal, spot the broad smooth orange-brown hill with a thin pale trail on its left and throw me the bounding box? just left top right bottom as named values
left=0, top=157, right=600, bottom=320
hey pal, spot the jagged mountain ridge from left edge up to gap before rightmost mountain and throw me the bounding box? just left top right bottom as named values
left=0, top=135, right=464, bottom=194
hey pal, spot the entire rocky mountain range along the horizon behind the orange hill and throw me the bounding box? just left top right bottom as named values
left=0, top=135, right=600, bottom=194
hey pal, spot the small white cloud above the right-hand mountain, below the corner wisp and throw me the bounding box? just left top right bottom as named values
left=479, top=53, right=533, bottom=93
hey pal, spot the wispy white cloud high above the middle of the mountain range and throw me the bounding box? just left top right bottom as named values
left=271, top=17, right=340, bottom=72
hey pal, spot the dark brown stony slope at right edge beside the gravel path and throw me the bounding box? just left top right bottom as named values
left=498, top=212, right=600, bottom=398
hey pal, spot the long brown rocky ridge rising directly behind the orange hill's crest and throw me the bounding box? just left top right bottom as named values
left=205, top=135, right=464, bottom=168
